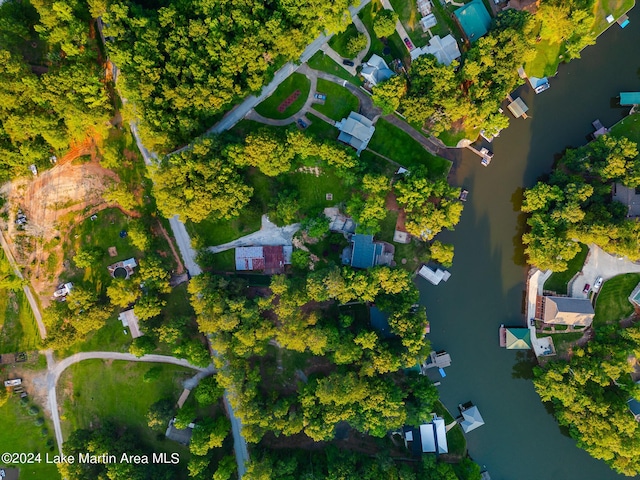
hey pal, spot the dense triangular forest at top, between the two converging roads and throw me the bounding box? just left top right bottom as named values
left=102, top=0, right=358, bottom=153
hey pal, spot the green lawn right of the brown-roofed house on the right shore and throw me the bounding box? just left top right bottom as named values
left=593, top=273, right=640, bottom=326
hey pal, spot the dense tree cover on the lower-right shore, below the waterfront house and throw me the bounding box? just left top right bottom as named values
left=534, top=324, right=640, bottom=476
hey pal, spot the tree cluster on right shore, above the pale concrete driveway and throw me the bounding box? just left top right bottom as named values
left=521, top=135, right=640, bottom=272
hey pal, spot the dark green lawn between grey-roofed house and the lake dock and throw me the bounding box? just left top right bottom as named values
left=369, top=119, right=451, bottom=178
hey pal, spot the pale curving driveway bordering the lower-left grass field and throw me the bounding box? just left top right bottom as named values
left=44, top=350, right=210, bottom=455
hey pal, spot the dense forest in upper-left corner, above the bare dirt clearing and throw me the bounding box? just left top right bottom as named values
left=0, top=0, right=113, bottom=181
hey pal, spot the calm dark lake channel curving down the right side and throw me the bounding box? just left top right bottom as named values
left=419, top=8, right=640, bottom=480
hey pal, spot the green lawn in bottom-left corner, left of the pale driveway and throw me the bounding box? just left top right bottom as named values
left=0, top=395, right=60, bottom=480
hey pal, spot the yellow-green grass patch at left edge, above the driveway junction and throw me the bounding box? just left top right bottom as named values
left=0, top=268, right=40, bottom=353
